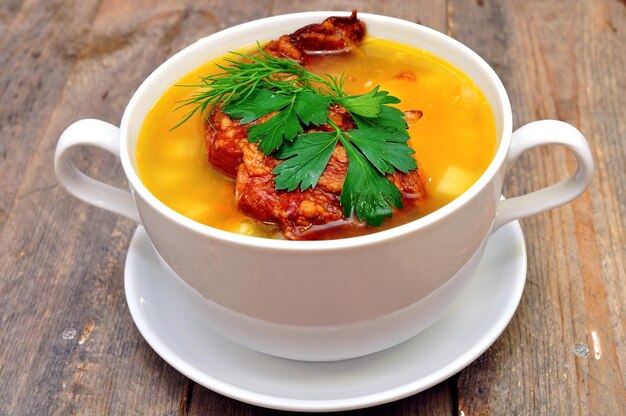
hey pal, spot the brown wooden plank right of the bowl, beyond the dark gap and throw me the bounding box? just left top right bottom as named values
left=450, top=1, right=626, bottom=414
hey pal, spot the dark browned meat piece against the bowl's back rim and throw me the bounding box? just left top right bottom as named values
left=263, top=11, right=365, bottom=65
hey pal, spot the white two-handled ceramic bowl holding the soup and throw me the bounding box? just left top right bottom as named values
left=55, top=12, right=593, bottom=360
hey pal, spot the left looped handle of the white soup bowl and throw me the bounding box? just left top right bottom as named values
left=54, top=119, right=141, bottom=223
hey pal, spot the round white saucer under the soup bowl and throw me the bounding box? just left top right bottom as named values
left=125, top=222, right=526, bottom=411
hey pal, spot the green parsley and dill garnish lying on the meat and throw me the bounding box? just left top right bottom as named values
left=174, top=44, right=417, bottom=226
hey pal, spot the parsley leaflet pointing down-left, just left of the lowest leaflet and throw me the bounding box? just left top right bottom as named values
left=272, top=132, right=339, bottom=192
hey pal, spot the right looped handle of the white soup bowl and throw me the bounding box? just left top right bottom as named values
left=493, top=120, right=594, bottom=231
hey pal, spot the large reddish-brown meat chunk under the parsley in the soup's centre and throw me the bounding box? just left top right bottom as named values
left=206, top=106, right=426, bottom=239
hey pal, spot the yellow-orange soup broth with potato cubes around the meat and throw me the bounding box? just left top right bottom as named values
left=137, top=37, right=496, bottom=238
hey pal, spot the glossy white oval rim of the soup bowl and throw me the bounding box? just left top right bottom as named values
left=120, top=11, right=512, bottom=252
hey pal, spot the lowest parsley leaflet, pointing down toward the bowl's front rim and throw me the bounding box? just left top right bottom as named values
left=339, top=135, right=402, bottom=227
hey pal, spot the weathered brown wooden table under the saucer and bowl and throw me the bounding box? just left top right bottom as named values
left=0, top=0, right=626, bottom=415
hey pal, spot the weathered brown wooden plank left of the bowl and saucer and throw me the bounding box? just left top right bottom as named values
left=0, top=1, right=266, bottom=414
